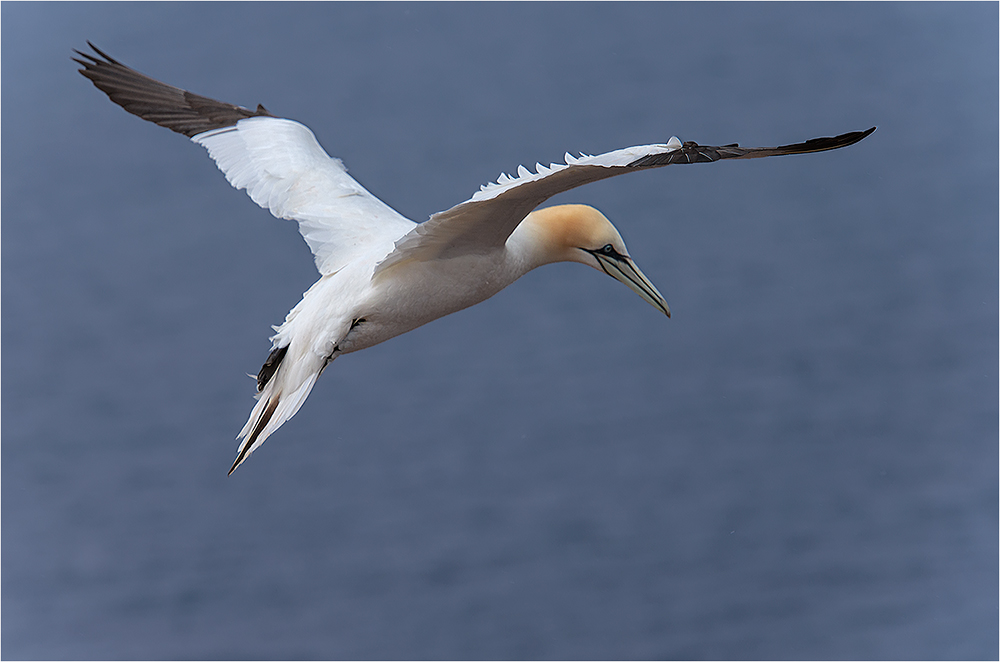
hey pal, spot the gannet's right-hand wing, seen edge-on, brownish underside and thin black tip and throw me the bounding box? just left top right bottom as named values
left=378, top=127, right=875, bottom=270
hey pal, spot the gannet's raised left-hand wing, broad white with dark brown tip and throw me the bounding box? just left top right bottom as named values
left=74, top=42, right=415, bottom=275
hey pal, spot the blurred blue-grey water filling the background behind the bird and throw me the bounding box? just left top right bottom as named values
left=0, top=3, right=1000, bottom=659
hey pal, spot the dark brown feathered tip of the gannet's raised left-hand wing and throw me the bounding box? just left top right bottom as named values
left=73, top=41, right=273, bottom=138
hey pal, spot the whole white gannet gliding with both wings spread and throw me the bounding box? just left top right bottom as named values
left=73, top=42, right=875, bottom=474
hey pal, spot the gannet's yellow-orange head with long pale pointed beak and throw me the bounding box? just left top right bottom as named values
left=521, top=205, right=670, bottom=317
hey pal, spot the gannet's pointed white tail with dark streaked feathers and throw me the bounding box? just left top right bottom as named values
left=229, top=346, right=326, bottom=475
